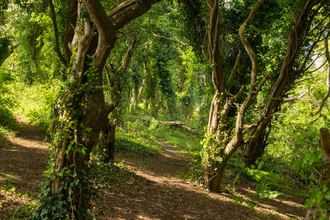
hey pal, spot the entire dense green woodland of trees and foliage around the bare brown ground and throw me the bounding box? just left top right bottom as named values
left=0, top=0, right=330, bottom=219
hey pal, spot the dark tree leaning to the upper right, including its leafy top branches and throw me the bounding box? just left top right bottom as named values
left=244, top=1, right=329, bottom=165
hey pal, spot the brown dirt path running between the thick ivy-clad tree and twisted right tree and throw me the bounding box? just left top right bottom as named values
left=102, top=141, right=306, bottom=220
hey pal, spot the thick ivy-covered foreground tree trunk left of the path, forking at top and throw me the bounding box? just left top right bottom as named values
left=35, top=0, right=159, bottom=219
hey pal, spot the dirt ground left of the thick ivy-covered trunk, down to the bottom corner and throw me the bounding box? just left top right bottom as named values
left=0, top=116, right=50, bottom=219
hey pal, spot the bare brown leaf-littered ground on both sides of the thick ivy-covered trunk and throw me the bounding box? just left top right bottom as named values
left=0, top=117, right=306, bottom=220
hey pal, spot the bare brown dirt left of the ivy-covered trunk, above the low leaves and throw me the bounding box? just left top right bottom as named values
left=0, top=116, right=50, bottom=195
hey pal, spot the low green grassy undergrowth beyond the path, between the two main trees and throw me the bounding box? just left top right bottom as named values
left=115, top=112, right=203, bottom=182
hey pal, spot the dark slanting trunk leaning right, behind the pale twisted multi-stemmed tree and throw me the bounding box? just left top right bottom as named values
left=244, top=0, right=326, bottom=166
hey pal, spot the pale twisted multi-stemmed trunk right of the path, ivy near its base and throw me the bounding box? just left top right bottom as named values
left=204, top=0, right=262, bottom=192
